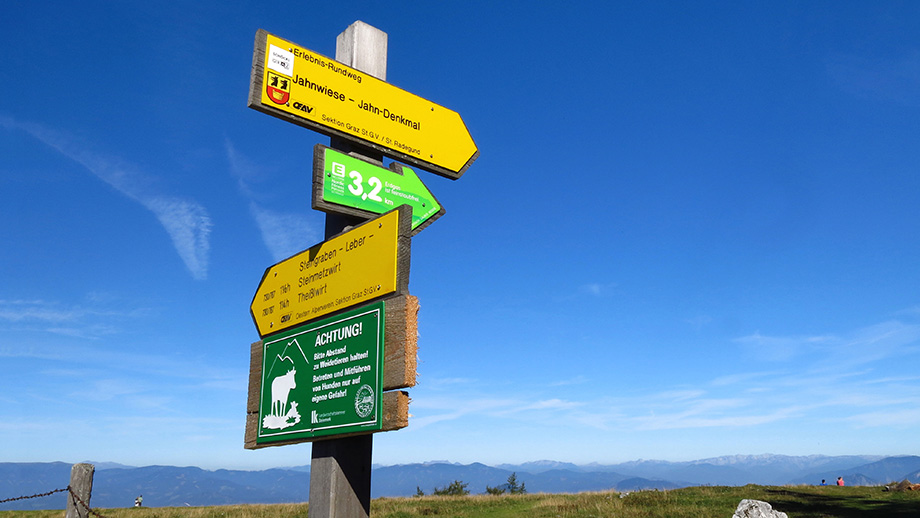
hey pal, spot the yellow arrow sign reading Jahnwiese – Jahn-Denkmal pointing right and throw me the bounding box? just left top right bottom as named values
left=249, top=29, right=479, bottom=179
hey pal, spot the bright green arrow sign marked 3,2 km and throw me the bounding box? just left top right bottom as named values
left=313, top=144, right=445, bottom=235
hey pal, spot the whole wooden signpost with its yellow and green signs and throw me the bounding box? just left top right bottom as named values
left=244, top=22, right=479, bottom=518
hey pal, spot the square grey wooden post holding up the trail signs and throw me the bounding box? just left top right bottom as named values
left=308, top=21, right=387, bottom=518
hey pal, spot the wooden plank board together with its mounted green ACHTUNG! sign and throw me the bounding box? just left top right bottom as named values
left=244, top=295, right=419, bottom=449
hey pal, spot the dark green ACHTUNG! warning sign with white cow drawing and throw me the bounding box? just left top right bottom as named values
left=256, top=301, right=384, bottom=444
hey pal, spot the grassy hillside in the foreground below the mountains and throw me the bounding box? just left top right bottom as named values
left=7, top=486, right=920, bottom=518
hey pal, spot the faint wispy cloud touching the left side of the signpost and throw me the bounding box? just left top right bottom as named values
left=225, top=141, right=322, bottom=261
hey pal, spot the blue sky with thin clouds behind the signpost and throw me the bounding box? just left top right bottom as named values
left=0, top=1, right=920, bottom=469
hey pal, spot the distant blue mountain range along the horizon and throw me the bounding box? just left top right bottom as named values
left=0, top=455, right=920, bottom=511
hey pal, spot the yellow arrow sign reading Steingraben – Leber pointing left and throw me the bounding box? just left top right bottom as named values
left=250, top=209, right=412, bottom=336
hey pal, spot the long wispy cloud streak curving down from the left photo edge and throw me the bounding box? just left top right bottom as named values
left=0, top=116, right=212, bottom=280
